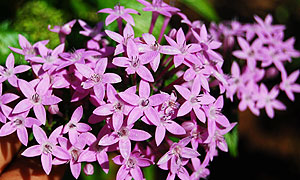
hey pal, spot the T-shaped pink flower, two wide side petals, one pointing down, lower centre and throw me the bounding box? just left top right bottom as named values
left=99, top=124, right=151, bottom=159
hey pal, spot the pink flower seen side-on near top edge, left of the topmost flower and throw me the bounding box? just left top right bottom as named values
left=98, top=4, right=139, bottom=26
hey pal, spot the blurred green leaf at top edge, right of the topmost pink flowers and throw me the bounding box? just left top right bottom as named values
left=180, top=0, right=220, bottom=22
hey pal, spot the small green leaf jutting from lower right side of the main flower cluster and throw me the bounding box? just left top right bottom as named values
left=224, top=126, right=239, bottom=157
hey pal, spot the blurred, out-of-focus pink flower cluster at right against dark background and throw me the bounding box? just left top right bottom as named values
left=211, top=15, right=300, bottom=118
